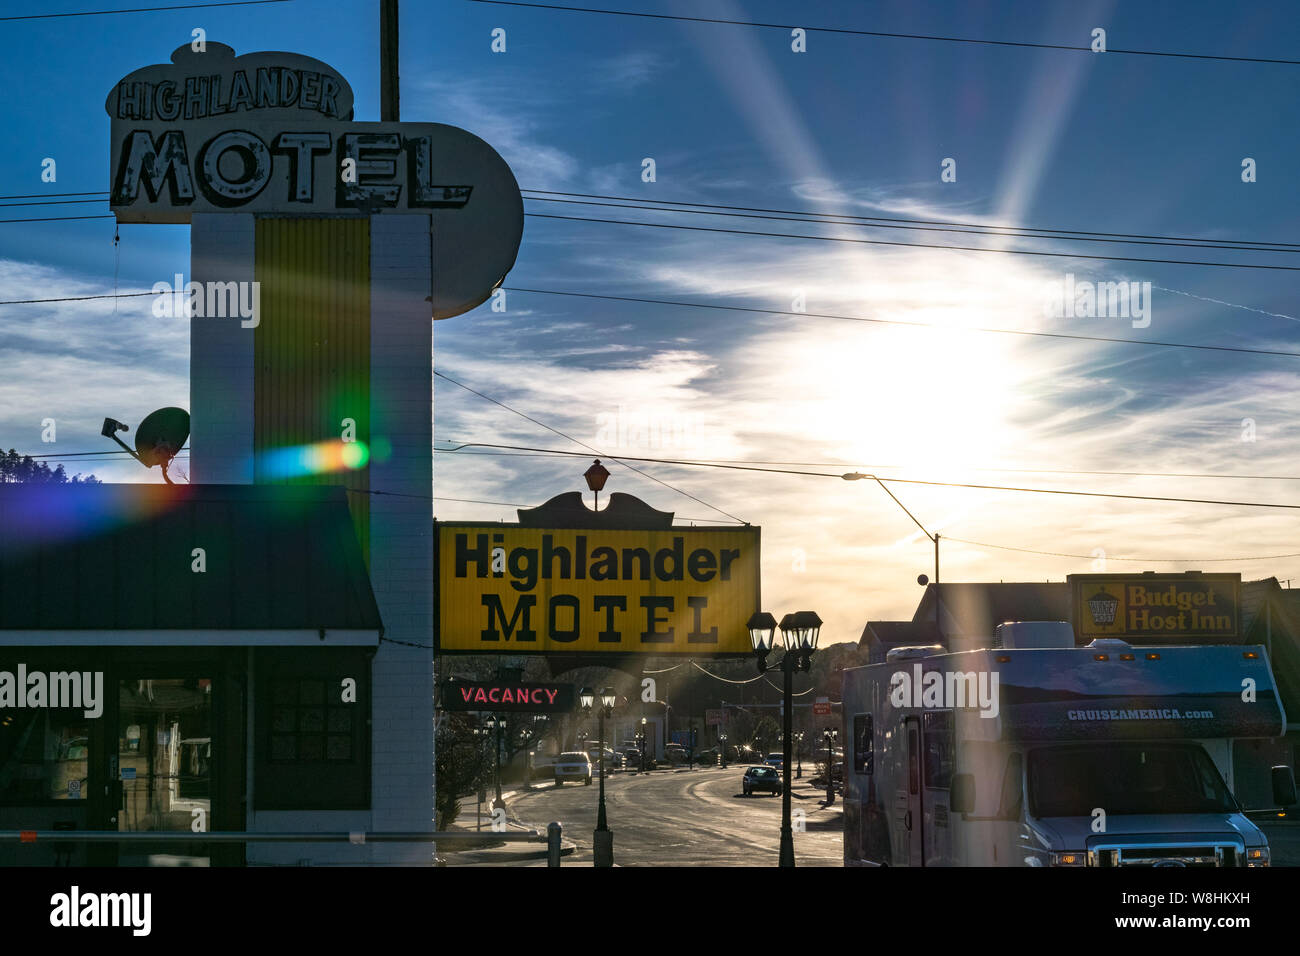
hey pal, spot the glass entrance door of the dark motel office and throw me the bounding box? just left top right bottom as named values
left=113, top=678, right=213, bottom=866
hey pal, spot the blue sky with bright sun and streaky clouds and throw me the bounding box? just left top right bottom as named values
left=0, top=0, right=1300, bottom=641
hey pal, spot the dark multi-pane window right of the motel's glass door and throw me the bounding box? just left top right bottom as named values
left=270, top=676, right=356, bottom=763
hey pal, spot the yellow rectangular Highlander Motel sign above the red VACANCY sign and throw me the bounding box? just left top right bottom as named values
left=436, top=523, right=759, bottom=657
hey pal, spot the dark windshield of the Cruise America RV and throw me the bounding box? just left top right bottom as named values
left=1028, top=743, right=1238, bottom=817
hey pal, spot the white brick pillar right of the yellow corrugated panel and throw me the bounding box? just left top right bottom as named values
left=371, top=215, right=434, bottom=864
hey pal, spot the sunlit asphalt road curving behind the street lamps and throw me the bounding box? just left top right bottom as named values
left=496, top=765, right=844, bottom=866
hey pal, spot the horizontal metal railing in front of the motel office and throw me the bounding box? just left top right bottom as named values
left=0, top=823, right=563, bottom=866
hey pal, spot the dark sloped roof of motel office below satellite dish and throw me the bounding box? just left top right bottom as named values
left=0, top=484, right=381, bottom=632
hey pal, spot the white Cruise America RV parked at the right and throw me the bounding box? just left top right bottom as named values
left=842, top=622, right=1296, bottom=866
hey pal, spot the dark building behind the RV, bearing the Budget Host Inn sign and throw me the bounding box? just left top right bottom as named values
left=858, top=571, right=1300, bottom=809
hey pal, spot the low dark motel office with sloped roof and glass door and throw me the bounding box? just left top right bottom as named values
left=0, top=485, right=382, bottom=865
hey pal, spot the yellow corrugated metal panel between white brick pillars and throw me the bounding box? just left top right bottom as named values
left=254, top=219, right=371, bottom=564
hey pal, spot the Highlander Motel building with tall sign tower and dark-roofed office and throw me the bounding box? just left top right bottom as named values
left=0, top=40, right=523, bottom=865
